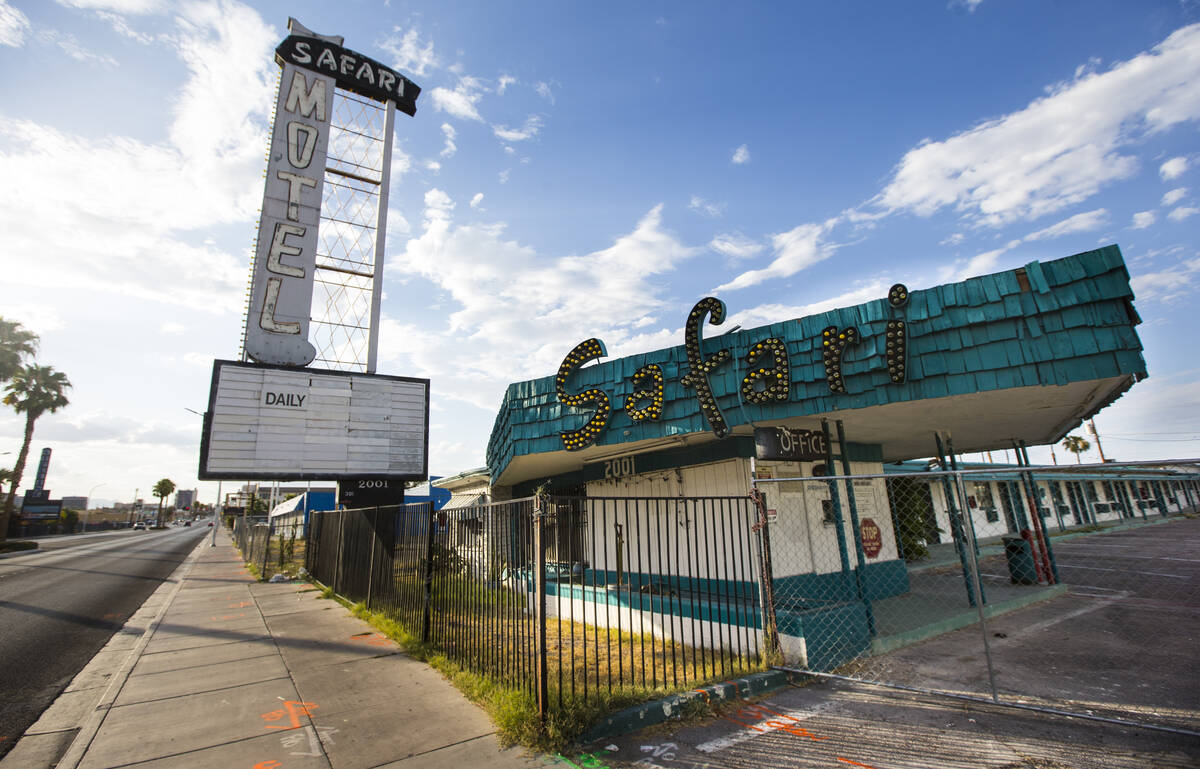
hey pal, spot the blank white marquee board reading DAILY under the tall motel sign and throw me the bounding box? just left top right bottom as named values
left=199, top=360, right=430, bottom=480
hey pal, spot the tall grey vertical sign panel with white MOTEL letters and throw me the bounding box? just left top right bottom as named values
left=246, top=54, right=335, bottom=366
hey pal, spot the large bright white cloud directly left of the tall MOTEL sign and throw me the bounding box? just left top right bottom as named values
left=0, top=2, right=277, bottom=313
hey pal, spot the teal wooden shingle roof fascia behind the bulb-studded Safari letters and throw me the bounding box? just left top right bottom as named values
left=487, top=246, right=1146, bottom=480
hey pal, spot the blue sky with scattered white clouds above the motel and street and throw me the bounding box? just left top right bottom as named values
left=0, top=0, right=1200, bottom=501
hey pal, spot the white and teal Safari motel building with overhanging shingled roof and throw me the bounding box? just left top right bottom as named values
left=439, top=246, right=1200, bottom=668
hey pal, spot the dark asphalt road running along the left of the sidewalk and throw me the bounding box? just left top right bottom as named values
left=0, top=525, right=210, bottom=756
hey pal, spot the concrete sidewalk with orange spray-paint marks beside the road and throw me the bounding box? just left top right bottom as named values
left=0, top=530, right=544, bottom=769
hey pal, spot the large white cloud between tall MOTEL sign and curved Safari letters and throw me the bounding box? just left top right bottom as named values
left=380, top=197, right=697, bottom=413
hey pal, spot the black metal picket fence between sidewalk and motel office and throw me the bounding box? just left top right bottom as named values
left=304, top=497, right=763, bottom=715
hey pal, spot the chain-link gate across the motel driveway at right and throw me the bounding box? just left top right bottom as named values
left=754, top=463, right=1200, bottom=735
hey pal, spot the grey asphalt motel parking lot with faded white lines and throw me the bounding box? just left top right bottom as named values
left=580, top=517, right=1200, bottom=769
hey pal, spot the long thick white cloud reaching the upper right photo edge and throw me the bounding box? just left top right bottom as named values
left=874, top=25, right=1200, bottom=226
